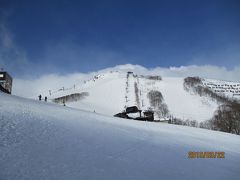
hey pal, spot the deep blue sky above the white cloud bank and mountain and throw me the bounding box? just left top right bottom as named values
left=0, top=0, right=240, bottom=76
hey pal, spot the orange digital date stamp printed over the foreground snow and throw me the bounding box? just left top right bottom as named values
left=188, top=151, right=225, bottom=159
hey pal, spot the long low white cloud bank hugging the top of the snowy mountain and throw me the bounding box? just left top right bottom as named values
left=13, top=64, right=240, bottom=98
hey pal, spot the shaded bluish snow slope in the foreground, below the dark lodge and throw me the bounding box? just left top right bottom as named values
left=0, top=93, right=240, bottom=180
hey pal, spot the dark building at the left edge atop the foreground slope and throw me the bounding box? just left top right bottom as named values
left=0, top=71, right=12, bottom=94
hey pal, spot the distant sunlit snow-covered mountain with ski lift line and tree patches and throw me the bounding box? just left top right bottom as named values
left=42, top=69, right=240, bottom=122
